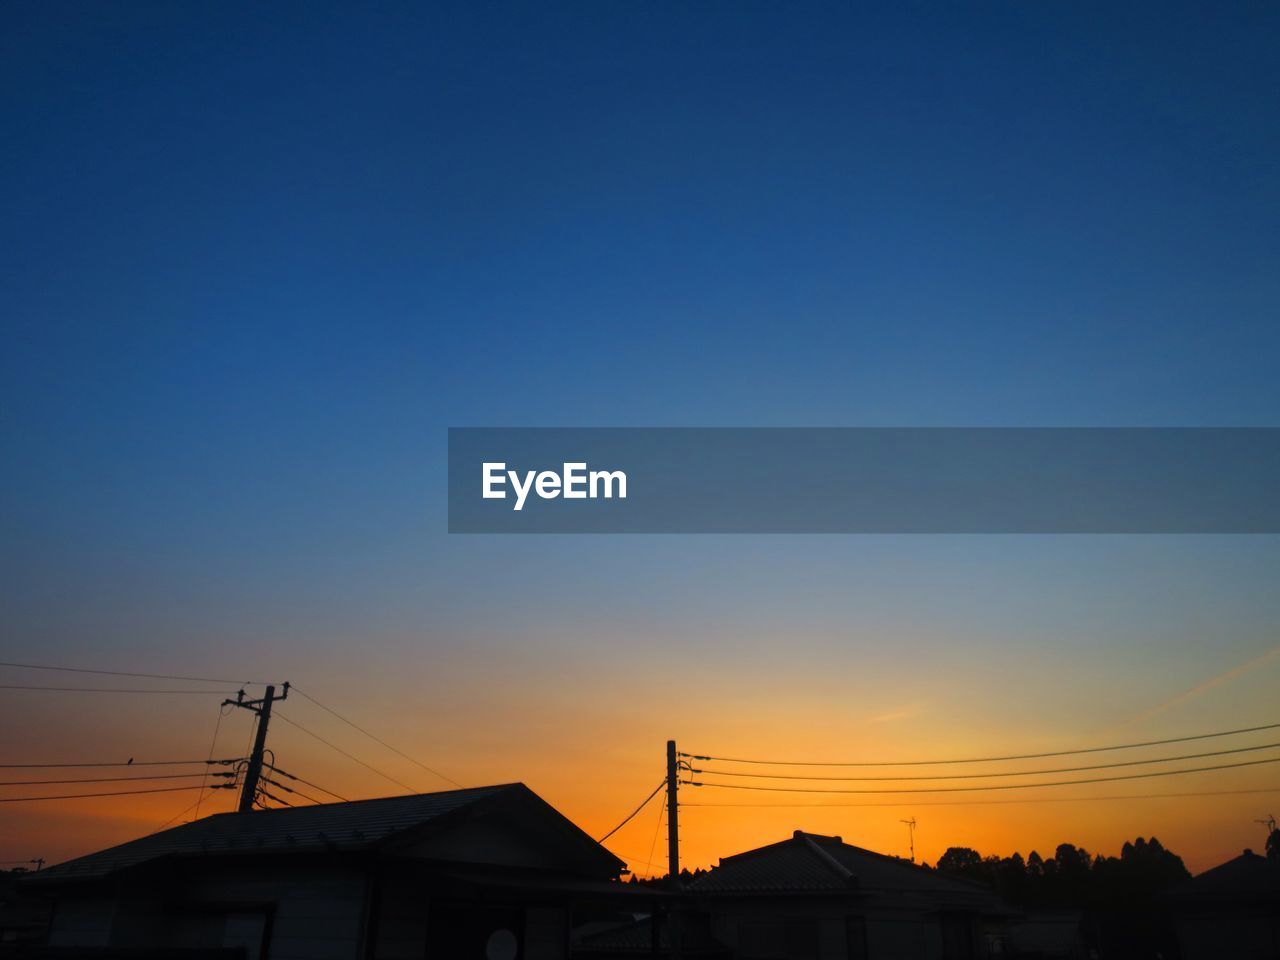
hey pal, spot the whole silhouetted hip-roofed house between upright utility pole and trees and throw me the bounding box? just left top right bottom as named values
left=687, top=831, right=1016, bottom=960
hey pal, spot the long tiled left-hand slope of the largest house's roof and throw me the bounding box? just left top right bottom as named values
left=26, top=783, right=514, bottom=883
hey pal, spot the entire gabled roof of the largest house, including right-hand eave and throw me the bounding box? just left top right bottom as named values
left=26, top=783, right=623, bottom=883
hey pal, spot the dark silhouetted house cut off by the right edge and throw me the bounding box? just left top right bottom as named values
left=1166, top=850, right=1280, bottom=960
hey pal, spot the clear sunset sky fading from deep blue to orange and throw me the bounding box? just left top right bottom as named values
left=0, top=3, right=1280, bottom=874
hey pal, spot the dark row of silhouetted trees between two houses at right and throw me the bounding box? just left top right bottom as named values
left=936, top=837, right=1190, bottom=908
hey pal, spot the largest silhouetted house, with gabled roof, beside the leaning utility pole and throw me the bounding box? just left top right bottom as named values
left=23, top=783, right=653, bottom=960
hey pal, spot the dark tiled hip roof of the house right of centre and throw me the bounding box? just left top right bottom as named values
left=690, top=829, right=1009, bottom=913
